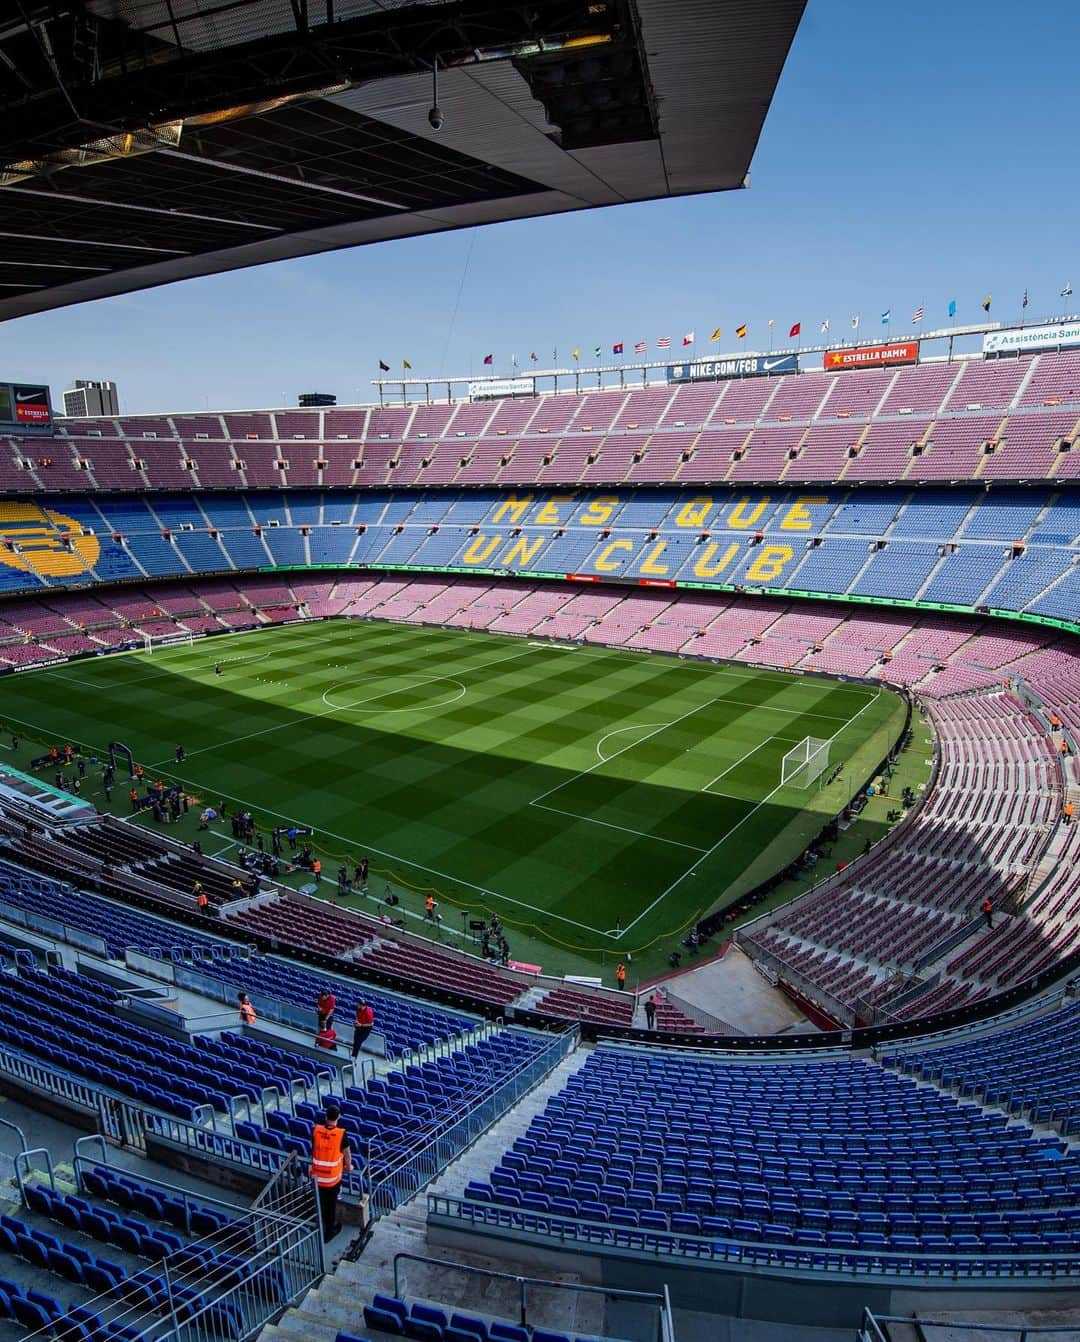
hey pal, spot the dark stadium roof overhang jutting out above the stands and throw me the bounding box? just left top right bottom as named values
left=0, top=0, right=805, bottom=319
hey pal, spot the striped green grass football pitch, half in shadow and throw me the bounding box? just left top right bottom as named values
left=0, top=620, right=904, bottom=960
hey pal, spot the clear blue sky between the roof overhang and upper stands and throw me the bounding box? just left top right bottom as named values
left=0, top=0, right=1080, bottom=412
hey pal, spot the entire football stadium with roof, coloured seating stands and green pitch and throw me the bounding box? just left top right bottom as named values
left=0, top=0, right=1080, bottom=1342
